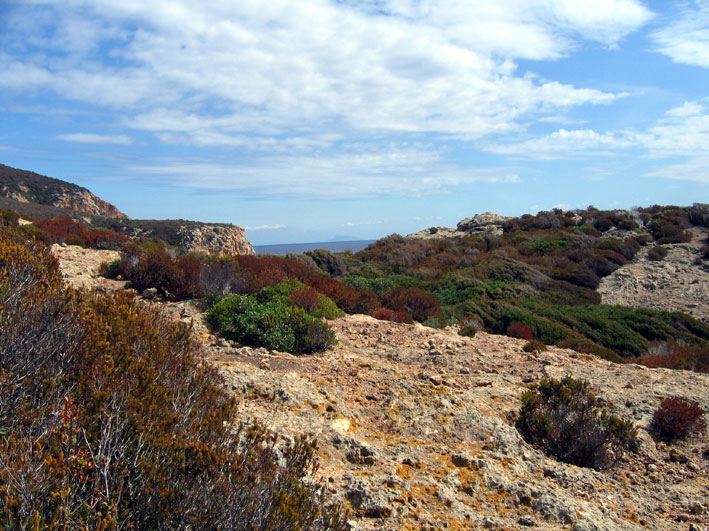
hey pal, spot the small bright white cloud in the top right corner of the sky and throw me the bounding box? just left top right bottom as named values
left=652, top=0, right=709, bottom=68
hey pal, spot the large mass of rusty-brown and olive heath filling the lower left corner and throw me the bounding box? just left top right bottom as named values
left=0, top=234, right=344, bottom=531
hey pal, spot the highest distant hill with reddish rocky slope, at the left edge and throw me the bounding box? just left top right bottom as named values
left=0, top=164, right=128, bottom=219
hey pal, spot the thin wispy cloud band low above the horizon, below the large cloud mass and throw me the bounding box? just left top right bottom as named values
left=126, top=144, right=518, bottom=199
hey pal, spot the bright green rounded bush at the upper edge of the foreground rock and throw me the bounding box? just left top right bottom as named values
left=207, top=295, right=335, bottom=354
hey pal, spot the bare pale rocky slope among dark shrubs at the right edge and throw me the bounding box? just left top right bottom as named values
left=598, top=227, right=709, bottom=322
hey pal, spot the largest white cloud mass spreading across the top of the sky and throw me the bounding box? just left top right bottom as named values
left=0, top=0, right=640, bottom=147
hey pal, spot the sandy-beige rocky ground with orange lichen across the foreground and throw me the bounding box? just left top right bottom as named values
left=55, top=248, right=709, bottom=530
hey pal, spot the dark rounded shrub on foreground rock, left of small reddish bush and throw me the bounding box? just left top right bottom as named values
left=515, top=377, right=636, bottom=470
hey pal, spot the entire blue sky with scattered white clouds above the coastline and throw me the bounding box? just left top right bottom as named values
left=0, top=0, right=709, bottom=245
